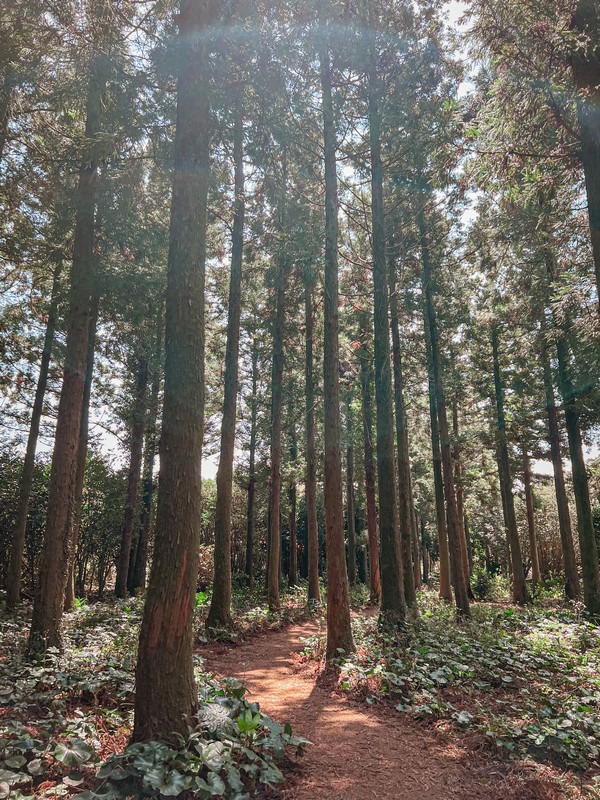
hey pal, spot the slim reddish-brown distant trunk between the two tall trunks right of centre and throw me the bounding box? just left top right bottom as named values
left=360, top=313, right=381, bottom=603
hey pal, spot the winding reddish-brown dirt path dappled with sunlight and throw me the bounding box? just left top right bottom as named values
left=201, top=621, right=565, bottom=800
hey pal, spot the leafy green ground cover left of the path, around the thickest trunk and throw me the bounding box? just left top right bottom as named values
left=0, top=599, right=305, bottom=800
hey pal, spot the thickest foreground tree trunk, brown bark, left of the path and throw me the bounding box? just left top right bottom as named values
left=133, top=0, right=212, bottom=741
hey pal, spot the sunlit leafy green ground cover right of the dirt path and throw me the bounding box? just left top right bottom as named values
left=304, top=591, right=600, bottom=777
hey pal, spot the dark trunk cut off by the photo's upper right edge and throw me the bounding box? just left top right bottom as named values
left=571, top=0, right=600, bottom=302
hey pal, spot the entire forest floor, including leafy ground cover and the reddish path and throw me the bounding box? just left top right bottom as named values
left=0, top=588, right=600, bottom=800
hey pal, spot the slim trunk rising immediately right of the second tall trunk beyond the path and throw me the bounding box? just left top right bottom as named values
left=388, top=241, right=418, bottom=608
